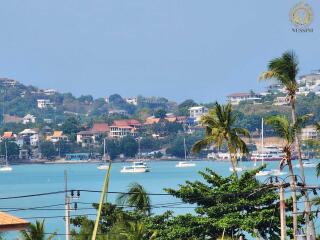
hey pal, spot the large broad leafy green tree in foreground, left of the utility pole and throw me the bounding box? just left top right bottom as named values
left=156, top=169, right=290, bottom=240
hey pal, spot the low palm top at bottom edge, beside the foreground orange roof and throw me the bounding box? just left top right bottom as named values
left=20, top=220, right=56, bottom=240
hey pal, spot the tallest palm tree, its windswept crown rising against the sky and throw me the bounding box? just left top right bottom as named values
left=259, top=51, right=316, bottom=236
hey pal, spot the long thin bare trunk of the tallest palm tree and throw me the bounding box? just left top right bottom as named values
left=291, top=99, right=316, bottom=240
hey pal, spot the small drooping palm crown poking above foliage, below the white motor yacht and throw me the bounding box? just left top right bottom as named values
left=116, top=183, right=151, bottom=214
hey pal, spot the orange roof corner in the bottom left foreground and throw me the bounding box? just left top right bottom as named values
left=0, top=212, right=29, bottom=232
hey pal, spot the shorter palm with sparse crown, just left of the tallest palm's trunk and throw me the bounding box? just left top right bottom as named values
left=266, top=115, right=307, bottom=238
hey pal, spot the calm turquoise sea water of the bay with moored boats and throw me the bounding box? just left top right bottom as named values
left=0, top=161, right=320, bottom=239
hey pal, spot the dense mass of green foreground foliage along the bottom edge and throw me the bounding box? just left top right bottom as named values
left=72, top=169, right=291, bottom=240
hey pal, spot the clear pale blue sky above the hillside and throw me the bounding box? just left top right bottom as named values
left=0, top=0, right=320, bottom=102
